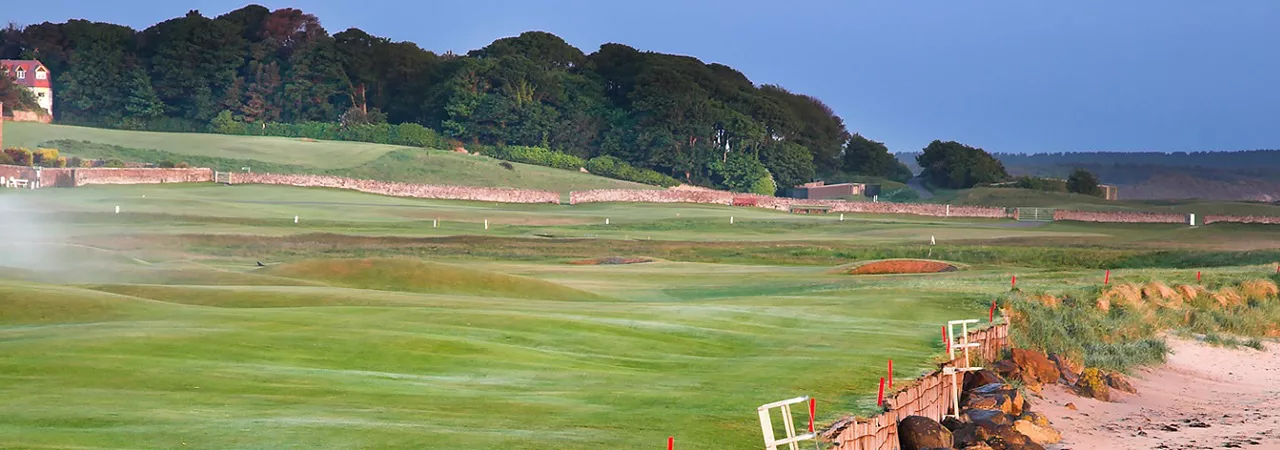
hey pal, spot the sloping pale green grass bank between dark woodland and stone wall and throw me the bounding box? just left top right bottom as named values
left=4, top=121, right=653, bottom=192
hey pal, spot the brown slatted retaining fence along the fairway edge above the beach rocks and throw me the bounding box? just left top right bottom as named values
left=820, top=323, right=1009, bottom=450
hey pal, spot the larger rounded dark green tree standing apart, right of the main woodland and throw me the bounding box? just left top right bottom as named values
left=915, top=141, right=1009, bottom=189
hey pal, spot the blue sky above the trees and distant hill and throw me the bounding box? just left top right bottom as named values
left=0, top=0, right=1280, bottom=152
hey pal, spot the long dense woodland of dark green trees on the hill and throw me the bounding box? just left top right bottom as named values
left=0, top=5, right=911, bottom=192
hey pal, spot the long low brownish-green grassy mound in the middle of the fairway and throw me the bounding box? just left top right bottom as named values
left=255, top=258, right=604, bottom=300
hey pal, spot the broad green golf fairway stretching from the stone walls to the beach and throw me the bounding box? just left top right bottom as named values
left=0, top=184, right=1280, bottom=450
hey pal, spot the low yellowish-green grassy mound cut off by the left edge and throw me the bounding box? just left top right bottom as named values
left=0, top=284, right=167, bottom=325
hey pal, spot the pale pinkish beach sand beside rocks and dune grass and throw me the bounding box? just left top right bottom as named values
left=1037, top=339, right=1280, bottom=450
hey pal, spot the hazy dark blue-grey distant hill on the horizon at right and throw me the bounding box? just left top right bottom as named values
left=897, top=150, right=1280, bottom=202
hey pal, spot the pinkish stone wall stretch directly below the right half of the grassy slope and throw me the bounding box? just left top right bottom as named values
left=232, top=174, right=561, bottom=205
